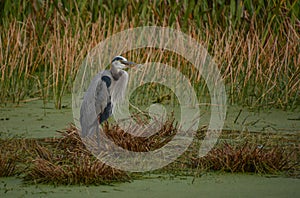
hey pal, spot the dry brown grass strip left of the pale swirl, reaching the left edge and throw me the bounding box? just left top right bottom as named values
left=0, top=126, right=131, bottom=185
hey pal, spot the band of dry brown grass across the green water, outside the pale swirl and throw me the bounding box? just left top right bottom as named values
left=0, top=120, right=300, bottom=185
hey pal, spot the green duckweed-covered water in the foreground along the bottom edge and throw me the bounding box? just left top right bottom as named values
left=0, top=173, right=300, bottom=198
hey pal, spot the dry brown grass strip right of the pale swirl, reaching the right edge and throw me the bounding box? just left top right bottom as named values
left=152, top=130, right=300, bottom=178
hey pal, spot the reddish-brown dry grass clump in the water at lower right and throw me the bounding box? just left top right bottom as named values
left=194, top=142, right=299, bottom=174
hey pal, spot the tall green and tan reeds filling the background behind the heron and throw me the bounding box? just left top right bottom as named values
left=0, top=0, right=300, bottom=108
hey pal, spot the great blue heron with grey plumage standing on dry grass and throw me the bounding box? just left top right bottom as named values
left=80, top=56, right=135, bottom=137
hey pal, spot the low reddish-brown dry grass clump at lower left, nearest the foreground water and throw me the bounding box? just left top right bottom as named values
left=24, top=155, right=130, bottom=185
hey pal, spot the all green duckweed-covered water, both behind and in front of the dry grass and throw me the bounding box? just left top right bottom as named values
left=0, top=96, right=300, bottom=197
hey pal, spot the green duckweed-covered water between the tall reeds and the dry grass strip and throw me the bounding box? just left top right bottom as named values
left=0, top=96, right=300, bottom=138
